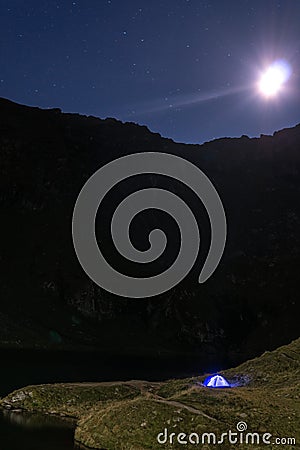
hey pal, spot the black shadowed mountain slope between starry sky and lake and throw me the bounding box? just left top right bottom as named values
left=0, top=99, right=300, bottom=365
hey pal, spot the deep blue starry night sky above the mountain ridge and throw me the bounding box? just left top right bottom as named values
left=0, top=0, right=300, bottom=143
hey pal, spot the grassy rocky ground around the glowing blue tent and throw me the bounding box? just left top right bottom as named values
left=1, top=338, right=300, bottom=450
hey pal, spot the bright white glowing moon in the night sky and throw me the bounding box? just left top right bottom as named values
left=258, top=60, right=291, bottom=98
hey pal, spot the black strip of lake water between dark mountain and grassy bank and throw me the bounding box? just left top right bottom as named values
left=0, top=350, right=228, bottom=397
